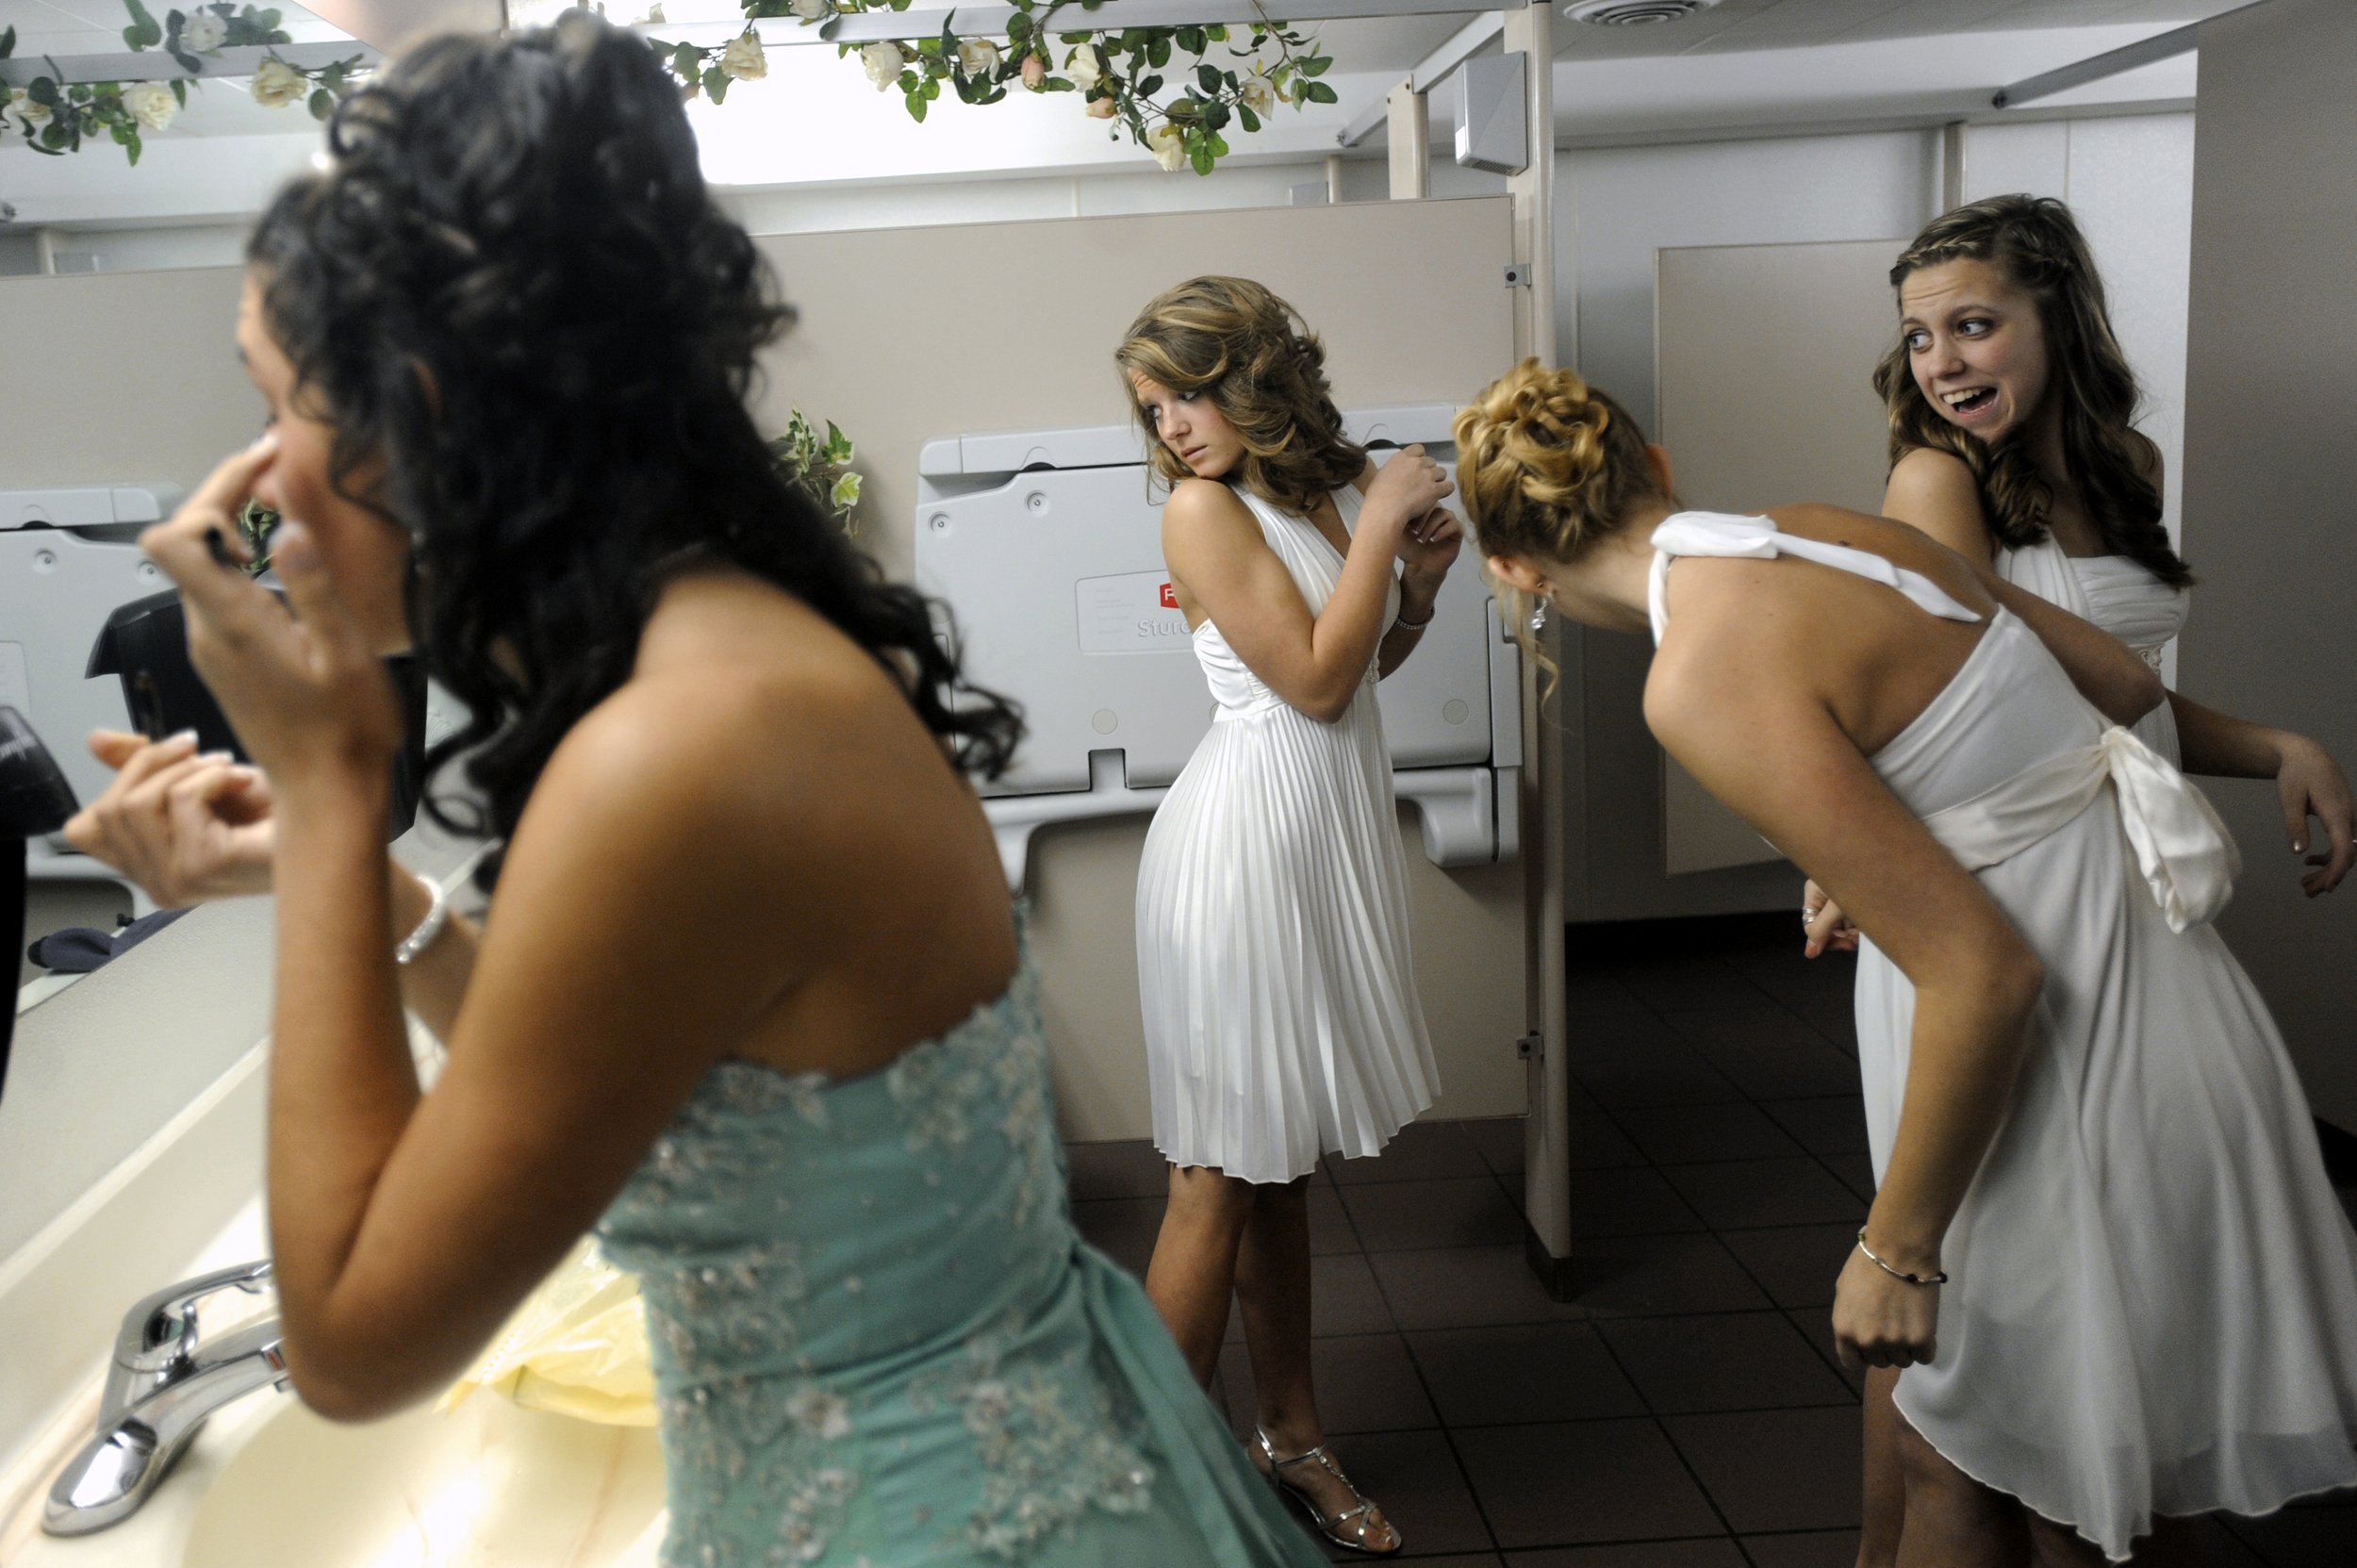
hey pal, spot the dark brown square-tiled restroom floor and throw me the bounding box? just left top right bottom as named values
left=1070, top=917, right=2357, bottom=1568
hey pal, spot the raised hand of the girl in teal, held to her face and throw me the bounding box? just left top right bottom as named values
left=140, top=437, right=401, bottom=800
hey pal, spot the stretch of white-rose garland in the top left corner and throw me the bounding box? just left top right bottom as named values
left=0, top=0, right=361, bottom=163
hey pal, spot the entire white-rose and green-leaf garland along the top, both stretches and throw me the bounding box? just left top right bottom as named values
left=0, top=0, right=1337, bottom=174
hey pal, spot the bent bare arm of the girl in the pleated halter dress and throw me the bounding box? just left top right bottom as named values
left=1162, top=448, right=1447, bottom=724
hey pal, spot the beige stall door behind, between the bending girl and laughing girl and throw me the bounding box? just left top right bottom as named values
left=1653, top=240, right=1907, bottom=875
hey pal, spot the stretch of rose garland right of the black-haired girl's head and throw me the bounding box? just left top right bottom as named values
left=649, top=0, right=1337, bottom=174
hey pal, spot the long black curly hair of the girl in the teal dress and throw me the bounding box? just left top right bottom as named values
left=248, top=12, right=1021, bottom=886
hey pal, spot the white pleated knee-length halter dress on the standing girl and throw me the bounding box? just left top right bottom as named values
left=1139, top=488, right=1441, bottom=1181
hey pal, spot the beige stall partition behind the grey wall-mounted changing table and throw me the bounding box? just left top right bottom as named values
left=759, top=201, right=1527, bottom=1139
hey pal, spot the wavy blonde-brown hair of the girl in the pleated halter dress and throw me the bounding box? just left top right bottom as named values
left=1113, top=276, right=1367, bottom=512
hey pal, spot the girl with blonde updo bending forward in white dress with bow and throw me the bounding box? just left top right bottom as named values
left=1457, top=361, right=2357, bottom=1568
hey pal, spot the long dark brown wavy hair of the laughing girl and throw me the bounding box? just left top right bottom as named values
left=1874, top=196, right=2195, bottom=587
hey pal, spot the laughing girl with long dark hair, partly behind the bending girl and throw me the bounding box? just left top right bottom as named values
left=1808, top=196, right=2357, bottom=1568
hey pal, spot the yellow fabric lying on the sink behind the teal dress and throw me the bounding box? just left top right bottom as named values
left=437, top=1238, right=655, bottom=1427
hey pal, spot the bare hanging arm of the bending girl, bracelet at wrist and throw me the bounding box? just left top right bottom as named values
left=1645, top=630, right=2044, bottom=1365
